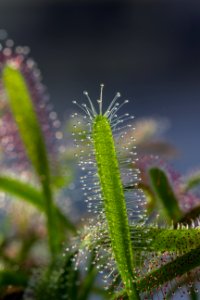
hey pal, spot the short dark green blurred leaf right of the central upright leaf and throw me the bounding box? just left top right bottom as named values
left=149, top=168, right=183, bottom=222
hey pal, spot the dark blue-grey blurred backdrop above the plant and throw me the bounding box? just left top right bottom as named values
left=0, top=0, right=200, bottom=170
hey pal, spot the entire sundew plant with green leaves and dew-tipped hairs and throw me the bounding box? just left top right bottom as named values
left=0, top=33, right=200, bottom=300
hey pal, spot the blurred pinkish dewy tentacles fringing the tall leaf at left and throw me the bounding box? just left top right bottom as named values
left=0, top=30, right=63, bottom=170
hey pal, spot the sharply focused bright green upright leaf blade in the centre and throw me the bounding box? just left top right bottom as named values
left=92, top=115, right=138, bottom=299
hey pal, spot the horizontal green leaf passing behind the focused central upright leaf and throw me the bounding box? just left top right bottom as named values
left=84, top=225, right=200, bottom=253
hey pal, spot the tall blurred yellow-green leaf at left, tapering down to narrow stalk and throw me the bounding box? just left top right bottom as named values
left=2, top=64, right=60, bottom=257
